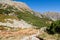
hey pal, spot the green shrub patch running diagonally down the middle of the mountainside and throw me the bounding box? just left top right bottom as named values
left=16, top=11, right=49, bottom=28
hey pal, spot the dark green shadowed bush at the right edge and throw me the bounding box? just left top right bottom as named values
left=47, top=20, right=60, bottom=34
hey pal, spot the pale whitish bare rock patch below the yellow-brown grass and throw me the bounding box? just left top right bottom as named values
left=0, top=19, right=32, bottom=29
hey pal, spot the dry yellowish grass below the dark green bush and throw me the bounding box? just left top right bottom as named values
left=39, top=32, right=60, bottom=40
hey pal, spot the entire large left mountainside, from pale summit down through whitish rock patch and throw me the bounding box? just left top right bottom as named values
left=0, top=0, right=51, bottom=28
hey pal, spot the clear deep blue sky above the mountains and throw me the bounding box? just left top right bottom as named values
left=15, top=0, right=60, bottom=13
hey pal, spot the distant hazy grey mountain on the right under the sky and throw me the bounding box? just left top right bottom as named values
left=44, top=12, right=60, bottom=21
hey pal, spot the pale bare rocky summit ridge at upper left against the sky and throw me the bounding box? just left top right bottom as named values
left=0, top=0, right=32, bottom=12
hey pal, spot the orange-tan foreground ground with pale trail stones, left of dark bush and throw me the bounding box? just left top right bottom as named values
left=0, top=29, right=39, bottom=40
